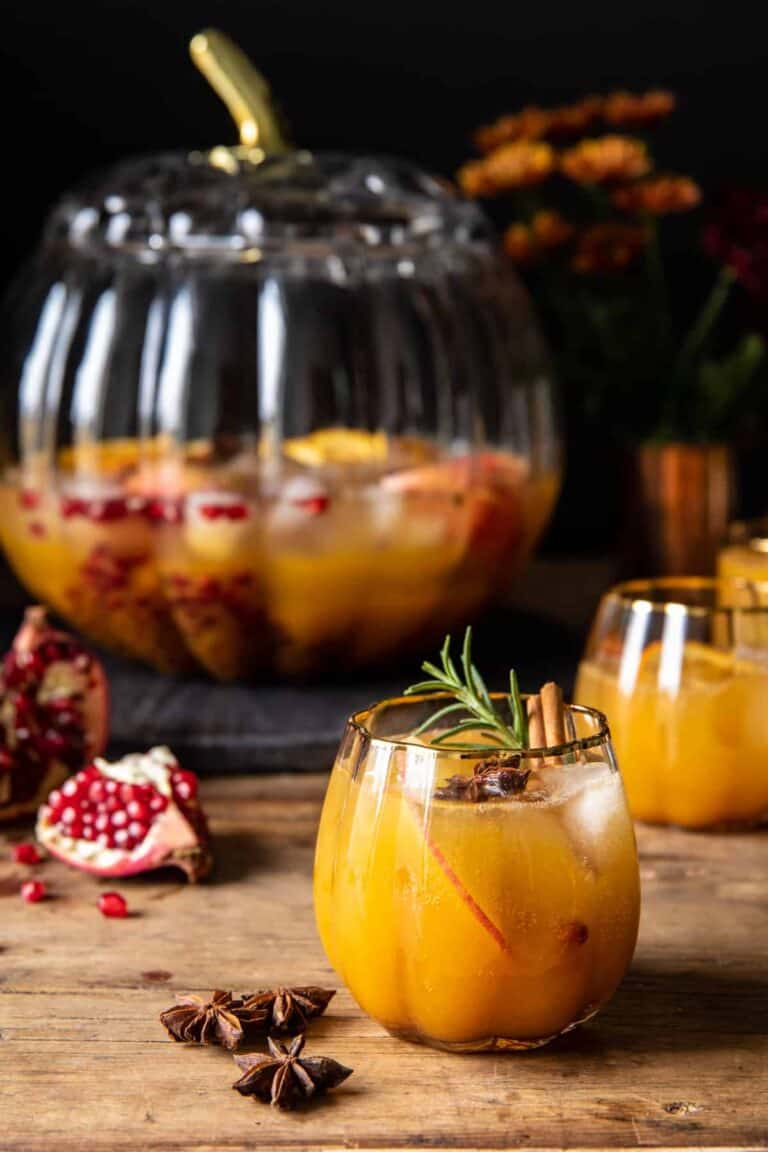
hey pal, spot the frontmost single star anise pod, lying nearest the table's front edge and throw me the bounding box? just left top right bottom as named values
left=233, top=1036, right=352, bottom=1109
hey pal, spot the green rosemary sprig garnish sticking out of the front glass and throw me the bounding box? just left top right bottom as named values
left=403, top=628, right=529, bottom=752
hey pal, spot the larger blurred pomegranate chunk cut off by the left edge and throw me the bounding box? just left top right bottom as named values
left=0, top=607, right=109, bottom=820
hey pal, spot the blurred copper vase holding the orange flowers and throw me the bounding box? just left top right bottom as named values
left=623, top=444, right=735, bottom=576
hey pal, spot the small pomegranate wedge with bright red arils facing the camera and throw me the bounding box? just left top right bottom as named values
left=37, top=748, right=211, bottom=880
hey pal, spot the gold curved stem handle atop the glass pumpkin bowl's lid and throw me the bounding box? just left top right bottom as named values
left=189, top=28, right=288, bottom=154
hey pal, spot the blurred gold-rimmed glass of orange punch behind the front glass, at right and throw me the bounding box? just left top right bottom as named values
left=576, top=577, right=768, bottom=828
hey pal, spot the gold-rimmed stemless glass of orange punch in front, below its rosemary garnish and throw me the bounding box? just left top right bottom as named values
left=314, top=696, right=640, bottom=1052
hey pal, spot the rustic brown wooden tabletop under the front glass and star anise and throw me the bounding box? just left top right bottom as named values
left=0, top=775, right=768, bottom=1152
